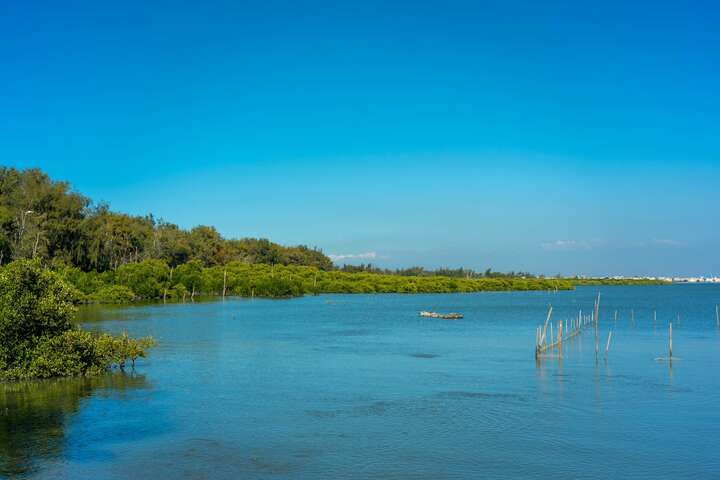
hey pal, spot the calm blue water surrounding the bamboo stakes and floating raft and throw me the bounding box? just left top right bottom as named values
left=0, top=285, right=720, bottom=479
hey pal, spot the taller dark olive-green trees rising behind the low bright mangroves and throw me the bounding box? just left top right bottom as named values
left=0, top=167, right=333, bottom=272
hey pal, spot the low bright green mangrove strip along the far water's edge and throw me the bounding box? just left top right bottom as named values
left=49, top=259, right=574, bottom=303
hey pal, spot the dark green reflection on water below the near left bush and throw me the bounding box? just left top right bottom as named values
left=0, top=373, right=148, bottom=477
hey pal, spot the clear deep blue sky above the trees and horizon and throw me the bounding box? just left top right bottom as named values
left=0, top=0, right=720, bottom=274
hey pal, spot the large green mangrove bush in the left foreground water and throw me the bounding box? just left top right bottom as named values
left=0, top=260, right=154, bottom=380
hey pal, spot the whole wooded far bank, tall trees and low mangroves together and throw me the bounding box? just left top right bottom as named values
left=0, top=167, right=572, bottom=303
